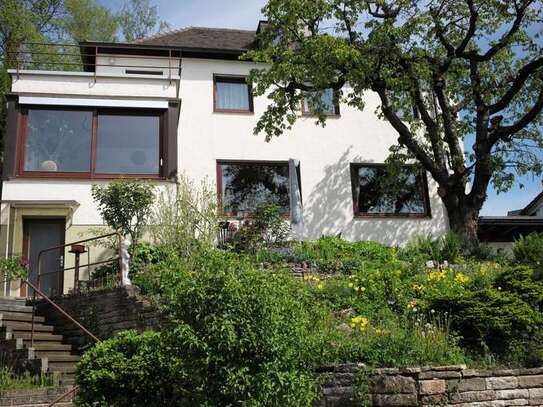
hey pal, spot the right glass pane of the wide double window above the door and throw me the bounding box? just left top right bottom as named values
left=96, top=114, right=160, bottom=175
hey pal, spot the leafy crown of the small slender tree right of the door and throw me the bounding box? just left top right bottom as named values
left=92, top=180, right=154, bottom=244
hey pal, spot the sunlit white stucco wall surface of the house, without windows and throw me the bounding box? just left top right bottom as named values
left=2, top=55, right=447, bottom=245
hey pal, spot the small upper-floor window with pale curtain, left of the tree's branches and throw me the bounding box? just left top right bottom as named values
left=213, top=76, right=253, bottom=113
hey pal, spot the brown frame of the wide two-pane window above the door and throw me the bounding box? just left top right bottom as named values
left=17, top=105, right=167, bottom=179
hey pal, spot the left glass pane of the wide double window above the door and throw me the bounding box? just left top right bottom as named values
left=24, top=109, right=92, bottom=172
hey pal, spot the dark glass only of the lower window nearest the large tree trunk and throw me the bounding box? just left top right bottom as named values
left=355, top=167, right=426, bottom=214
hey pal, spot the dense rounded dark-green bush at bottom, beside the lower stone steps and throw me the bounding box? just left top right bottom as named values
left=77, top=331, right=186, bottom=407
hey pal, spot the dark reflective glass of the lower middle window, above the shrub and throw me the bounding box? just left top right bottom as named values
left=221, top=163, right=290, bottom=214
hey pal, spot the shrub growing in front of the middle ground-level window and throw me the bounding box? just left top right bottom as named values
left=229, top=201, right=290, bottom=253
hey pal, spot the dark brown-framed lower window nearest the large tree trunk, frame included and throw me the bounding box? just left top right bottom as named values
left=351, top=164, right=430, bottom=217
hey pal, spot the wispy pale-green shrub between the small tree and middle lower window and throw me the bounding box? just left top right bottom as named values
left=150, top=175, right=219, bottom=257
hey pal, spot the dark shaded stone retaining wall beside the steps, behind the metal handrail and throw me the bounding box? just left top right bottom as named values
left=37, top=287, right=161, bottom=349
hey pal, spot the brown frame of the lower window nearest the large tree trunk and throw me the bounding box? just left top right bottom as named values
left=350, top=163, right=432, bottom=219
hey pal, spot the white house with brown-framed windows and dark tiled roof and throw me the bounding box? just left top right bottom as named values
left=1, top=22, right=448, bottom=293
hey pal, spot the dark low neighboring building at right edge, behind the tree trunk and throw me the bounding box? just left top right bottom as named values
left=479, top=188, right=543, bottom=251
